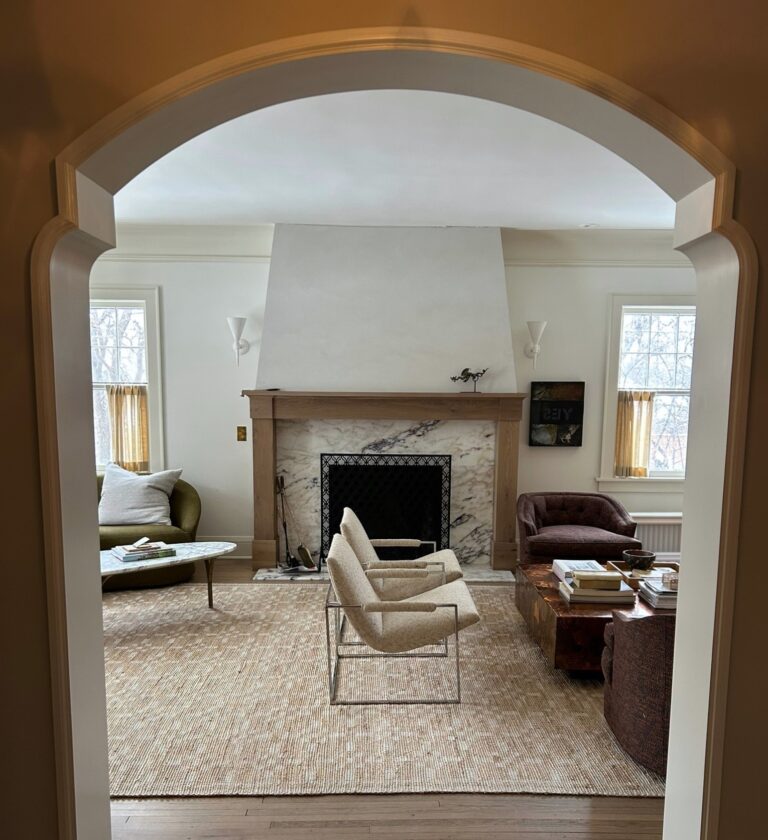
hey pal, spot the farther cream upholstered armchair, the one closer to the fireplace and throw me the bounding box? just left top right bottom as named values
left=341, top=508, right=464, bottom=601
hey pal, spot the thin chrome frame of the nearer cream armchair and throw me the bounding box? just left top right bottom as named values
left=325, top=585, right=461, bottom=706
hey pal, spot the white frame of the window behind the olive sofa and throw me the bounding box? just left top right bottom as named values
left=90, top=286, right=165, bottom=472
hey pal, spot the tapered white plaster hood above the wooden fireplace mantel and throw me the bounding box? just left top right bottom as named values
left=258, top=225, right=517, bottom=392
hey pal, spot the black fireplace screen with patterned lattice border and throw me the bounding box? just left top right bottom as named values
left=320, top=455, right=451, bottom=557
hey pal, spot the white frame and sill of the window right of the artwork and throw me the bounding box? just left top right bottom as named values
left=597, top=295, right=696, bottom=493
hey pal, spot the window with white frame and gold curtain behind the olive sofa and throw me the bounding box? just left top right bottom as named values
left=90, top=289, right=163, bottom=472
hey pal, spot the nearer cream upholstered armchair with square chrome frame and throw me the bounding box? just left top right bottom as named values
left=325, top=534, right=480, bottom=705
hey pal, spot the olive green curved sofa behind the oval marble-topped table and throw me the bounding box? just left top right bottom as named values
left=96, top=473, right=201, bottom=591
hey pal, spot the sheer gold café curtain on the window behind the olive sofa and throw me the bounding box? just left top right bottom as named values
left=107, top=385, right=149, bottom=472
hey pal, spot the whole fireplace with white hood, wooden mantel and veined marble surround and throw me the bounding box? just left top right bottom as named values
left=245, top=225, right=523, bottom=568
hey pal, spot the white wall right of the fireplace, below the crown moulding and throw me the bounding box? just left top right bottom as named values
left=506, top=258, right=696, bottom=512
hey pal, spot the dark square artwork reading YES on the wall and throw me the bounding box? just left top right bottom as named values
left=528, top=382, right=584, bottom=446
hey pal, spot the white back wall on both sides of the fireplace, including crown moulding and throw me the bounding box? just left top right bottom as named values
left=91, top=226, right=695, bottom=556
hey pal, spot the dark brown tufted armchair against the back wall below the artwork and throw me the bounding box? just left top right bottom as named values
left=517, top=493, right=643, bottom=563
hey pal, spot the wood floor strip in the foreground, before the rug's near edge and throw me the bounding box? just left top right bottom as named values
left=112, top=794, right=664, bottom=840
